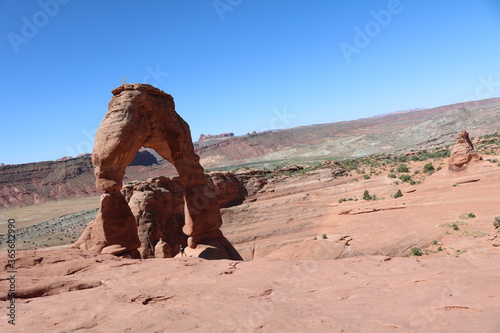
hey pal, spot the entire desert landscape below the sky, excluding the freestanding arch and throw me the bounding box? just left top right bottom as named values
left=0, top=88, right=500, bottom=333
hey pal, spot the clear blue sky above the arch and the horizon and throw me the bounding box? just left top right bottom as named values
left=0, top=0, right=500, bottom=164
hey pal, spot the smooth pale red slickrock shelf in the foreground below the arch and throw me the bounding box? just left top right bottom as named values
left=0, top=249, right=500, bottom=333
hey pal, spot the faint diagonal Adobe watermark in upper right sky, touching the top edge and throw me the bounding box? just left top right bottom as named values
left=339, top=0, right=403, bottom=64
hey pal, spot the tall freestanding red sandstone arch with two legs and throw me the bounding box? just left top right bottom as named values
left=83, top=84, right=242, bottom=260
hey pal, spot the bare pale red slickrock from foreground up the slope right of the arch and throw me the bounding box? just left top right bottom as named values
left=0, top=139, right=500, bottom=332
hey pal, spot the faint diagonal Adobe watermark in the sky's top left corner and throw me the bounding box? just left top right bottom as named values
left=7, top=0, right=70, bottom=53
